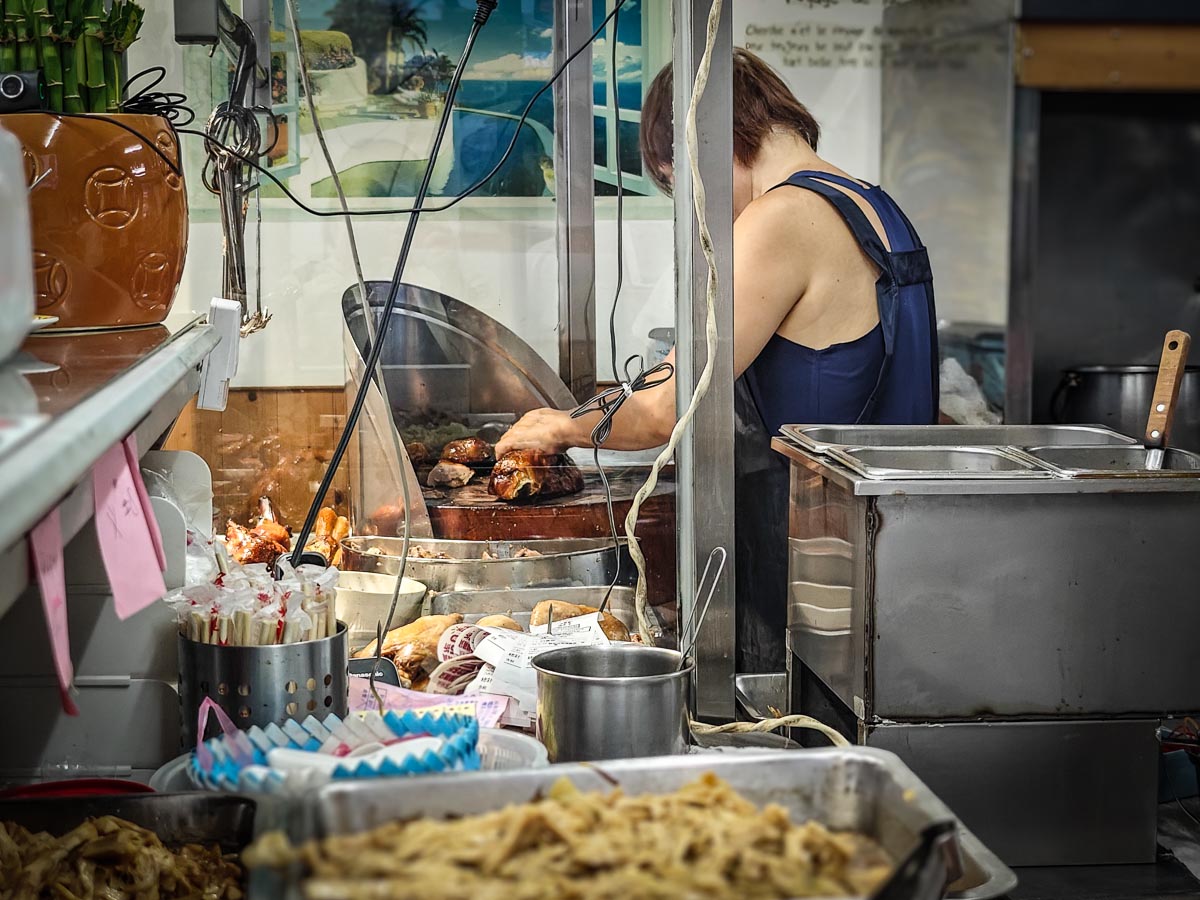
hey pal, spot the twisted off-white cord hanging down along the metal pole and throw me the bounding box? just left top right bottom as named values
left=625, top=0, right=724, bottom=643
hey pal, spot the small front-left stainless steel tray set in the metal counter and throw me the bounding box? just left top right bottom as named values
left=827, top=446, right=1051, bottom=481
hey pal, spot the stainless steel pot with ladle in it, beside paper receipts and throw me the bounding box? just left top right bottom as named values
left=533, top=643, right=691, bottom=762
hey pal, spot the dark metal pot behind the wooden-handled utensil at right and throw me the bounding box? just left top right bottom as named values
left=1050, top=366, right=1200, bottom=450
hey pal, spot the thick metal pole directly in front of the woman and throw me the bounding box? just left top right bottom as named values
left=673, top=0, right=737, bottom=719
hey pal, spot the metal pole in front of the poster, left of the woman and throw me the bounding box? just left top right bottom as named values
left=554, top=0, right=596, bottom=402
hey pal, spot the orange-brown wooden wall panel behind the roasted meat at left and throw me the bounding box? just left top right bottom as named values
left=166, top=388, right=349, bottom=529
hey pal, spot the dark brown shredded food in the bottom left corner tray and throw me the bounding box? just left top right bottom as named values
left=0, top=816, right=244, bottom=900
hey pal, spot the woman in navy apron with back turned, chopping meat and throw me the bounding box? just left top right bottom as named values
left=497, top=49, right=938, bottom=672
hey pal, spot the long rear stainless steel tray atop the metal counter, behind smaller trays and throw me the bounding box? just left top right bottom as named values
left=780, top=425, right=1138, bottom=455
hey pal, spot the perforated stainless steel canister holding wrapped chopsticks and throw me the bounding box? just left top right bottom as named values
left=179, top=622, right=349, bottom=749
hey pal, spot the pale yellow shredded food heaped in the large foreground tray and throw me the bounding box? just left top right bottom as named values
left=247, top=774, right=893, bottom=900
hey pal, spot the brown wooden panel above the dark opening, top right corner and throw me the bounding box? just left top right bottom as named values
left=1016, top=23, right=1200, bottom=91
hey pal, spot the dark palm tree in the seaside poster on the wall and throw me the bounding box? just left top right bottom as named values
left=329, top=0, right=428, bottom=94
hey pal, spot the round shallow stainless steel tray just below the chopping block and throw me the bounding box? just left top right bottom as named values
left=342, top=536, right=632, bottom=590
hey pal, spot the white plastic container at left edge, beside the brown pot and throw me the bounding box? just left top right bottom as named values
left=0, top=128, right=36, bottom=362
